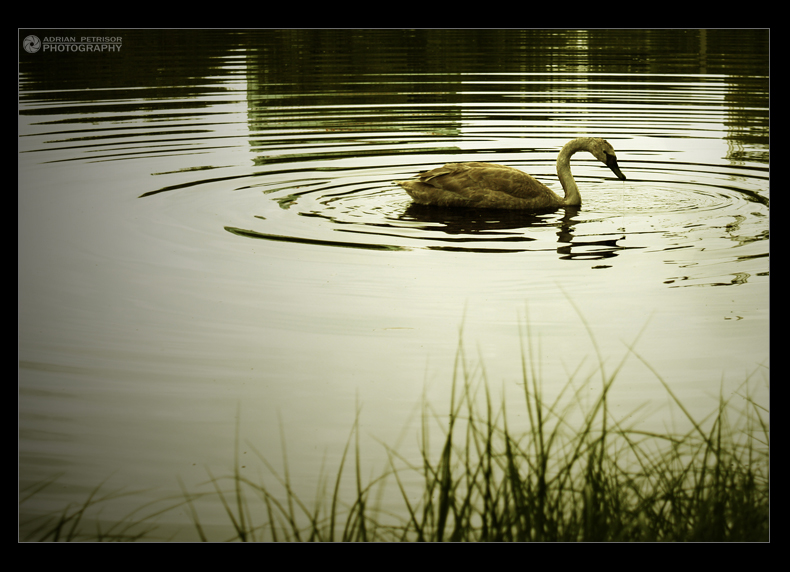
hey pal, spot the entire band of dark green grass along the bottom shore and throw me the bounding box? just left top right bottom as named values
left=20, top=322, right=769, bottom=542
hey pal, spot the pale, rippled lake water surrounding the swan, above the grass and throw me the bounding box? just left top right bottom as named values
left=18, top=30, right=769, bottom=539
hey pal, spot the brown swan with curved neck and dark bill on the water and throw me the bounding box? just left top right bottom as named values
left=394, top=137, right=625, bottom=210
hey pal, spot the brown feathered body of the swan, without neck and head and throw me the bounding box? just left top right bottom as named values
left=395, top=162, right=562, bottom=209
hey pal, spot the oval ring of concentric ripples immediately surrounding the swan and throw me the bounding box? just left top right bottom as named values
left=215, top=152, right=768, bottom=260
